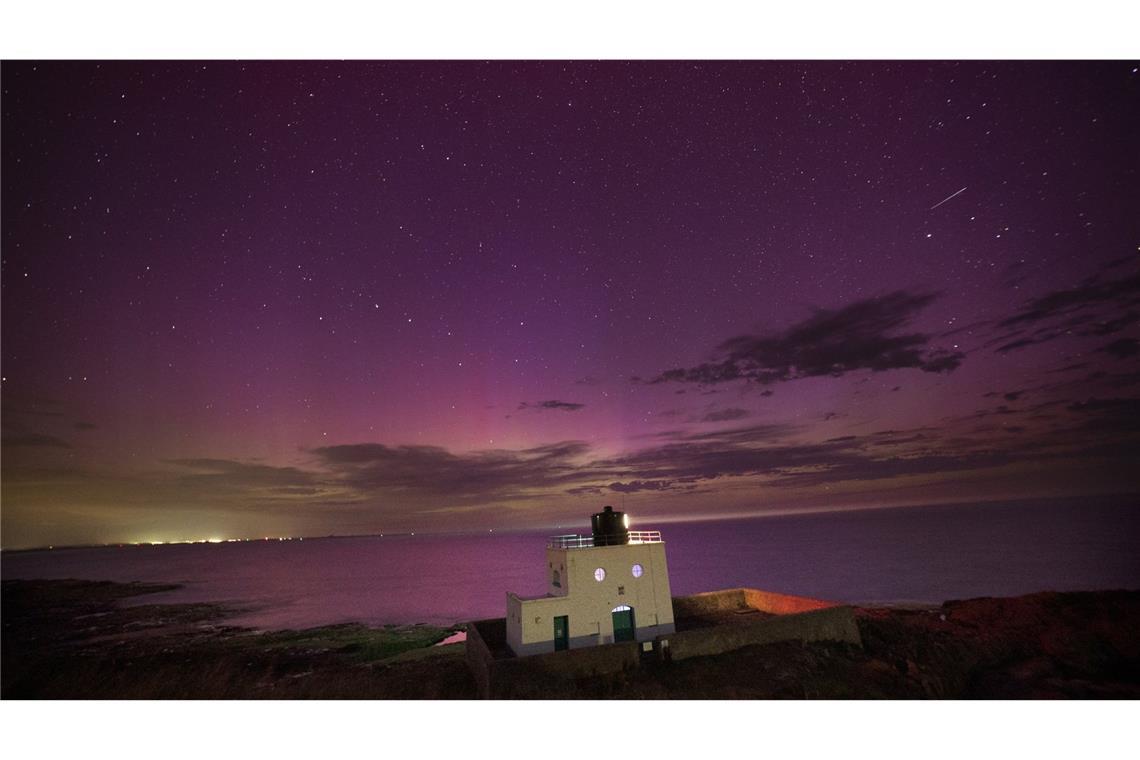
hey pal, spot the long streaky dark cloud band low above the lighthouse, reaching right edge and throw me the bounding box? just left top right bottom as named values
left=303, top=410, right=1140, bottom=505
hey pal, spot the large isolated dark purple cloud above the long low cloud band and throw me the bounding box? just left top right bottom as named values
left=650, top=291, right=964, bottom=385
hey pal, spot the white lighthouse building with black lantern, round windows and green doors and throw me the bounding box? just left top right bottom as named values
left=506, top=507, right=674, bottom=656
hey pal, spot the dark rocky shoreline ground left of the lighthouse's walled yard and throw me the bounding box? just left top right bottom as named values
left=0, top=581, right=474, bottom=700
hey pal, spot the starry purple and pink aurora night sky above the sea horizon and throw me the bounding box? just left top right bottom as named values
left=0, top=62, right=1140, bottom=548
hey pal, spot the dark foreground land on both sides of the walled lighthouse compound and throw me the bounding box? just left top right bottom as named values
left=0, top=581, right=1140, bottom=700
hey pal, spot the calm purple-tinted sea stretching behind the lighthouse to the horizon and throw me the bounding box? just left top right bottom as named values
left=2, top=497, right=1140, bottom=628
